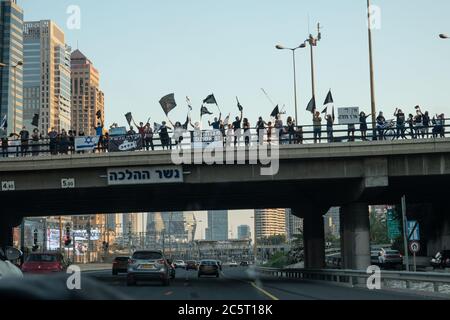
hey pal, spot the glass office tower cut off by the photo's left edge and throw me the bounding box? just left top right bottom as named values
left=0, top=0, right=23, bottom=134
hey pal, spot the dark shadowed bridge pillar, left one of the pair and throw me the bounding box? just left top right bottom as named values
left=303, top=208, right=325, bottom=269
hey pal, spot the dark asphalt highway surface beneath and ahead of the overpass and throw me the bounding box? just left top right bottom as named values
left=84, top=267, right=440, bottom=300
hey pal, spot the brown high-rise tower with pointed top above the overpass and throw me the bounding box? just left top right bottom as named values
left=71, top=50, right=105, bottom=135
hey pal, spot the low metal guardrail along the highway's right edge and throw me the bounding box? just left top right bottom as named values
left=256, top=267, right=450, bottom=294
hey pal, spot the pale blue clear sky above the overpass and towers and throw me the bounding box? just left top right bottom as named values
left=19, top=0, right=450, bottom=235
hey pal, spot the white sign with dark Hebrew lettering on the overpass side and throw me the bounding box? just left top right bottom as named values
left=108, top=166, right=183, bottom=186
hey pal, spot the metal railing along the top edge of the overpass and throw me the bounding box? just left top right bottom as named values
left=0, top=119, right=450, bottom=159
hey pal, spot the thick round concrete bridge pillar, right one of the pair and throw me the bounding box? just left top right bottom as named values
left=340, top=203, right=371, bottom=270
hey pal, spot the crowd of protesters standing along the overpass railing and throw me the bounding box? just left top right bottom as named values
left=0, top=106, right=445, bottom=157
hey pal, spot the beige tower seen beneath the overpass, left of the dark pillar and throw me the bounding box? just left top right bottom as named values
left=255, top=209, right=286, bottom=240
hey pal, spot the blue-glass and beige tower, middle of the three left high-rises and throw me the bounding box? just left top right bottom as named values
left=23, top=20, right=72, bottom=133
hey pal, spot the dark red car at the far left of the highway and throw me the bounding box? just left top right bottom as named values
left=22, top=252, right=69, bottom=274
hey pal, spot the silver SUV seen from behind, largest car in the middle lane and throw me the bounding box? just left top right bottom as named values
left=127, top=250, right=170, bottom=286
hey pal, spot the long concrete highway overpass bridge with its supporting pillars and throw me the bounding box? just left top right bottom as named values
left=0, top=139, right=450, bottom=268
